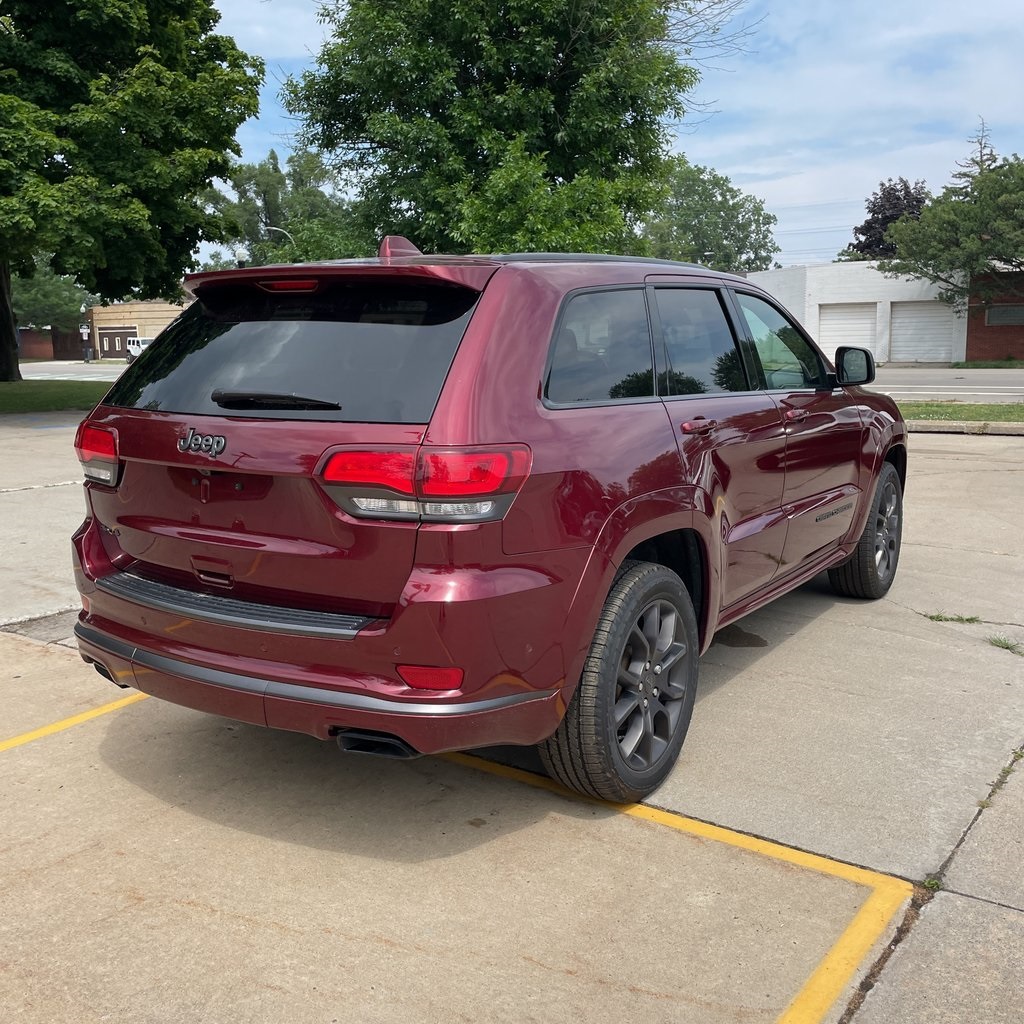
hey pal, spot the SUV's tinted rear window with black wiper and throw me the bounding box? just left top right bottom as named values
left=105, top=281, right=478, bottom=423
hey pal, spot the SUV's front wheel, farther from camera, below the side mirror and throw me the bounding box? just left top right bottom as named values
left=828, top=462, right=903, bottom=600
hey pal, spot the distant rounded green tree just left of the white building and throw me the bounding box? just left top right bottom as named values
left=642, top=156, right=779, bottom=271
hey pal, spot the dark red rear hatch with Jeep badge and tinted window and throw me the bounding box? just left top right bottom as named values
left=80, top=263, right=497, bottom=617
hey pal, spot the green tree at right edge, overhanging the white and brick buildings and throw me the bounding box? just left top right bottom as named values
left=879, top=122, right=1024, bottom=309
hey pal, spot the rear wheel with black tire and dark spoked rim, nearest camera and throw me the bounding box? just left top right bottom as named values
left=539, top=562, right=699, bottom=803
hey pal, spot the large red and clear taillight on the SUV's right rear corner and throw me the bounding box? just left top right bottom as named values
left=322, top=444, right=531, bottom=522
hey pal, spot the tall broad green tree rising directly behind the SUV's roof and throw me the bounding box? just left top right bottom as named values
left=285, top=0, right=708, bottom=252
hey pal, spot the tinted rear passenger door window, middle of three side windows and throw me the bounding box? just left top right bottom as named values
left=655, top=288, right=749, bottom=395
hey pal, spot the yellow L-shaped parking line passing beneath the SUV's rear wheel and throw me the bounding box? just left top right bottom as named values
left=444, top=754, right=913, bottom=1024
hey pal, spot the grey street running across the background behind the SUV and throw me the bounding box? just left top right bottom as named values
left=22, top=360, right=1024, bottom=402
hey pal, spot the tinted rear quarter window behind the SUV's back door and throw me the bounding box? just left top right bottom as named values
left=544, top=289, right=654, bottom=404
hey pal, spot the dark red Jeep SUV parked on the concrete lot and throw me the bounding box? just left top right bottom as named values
left=74, top=239, right=906, bottom=800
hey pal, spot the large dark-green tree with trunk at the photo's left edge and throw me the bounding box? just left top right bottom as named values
left=0, top=0, right=262, bottom=380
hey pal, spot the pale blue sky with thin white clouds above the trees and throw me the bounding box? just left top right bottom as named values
left=214, top=0, right=1024, bottom=265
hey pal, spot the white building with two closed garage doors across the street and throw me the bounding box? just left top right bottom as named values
left=746, top=262, right=967, bottom=362
